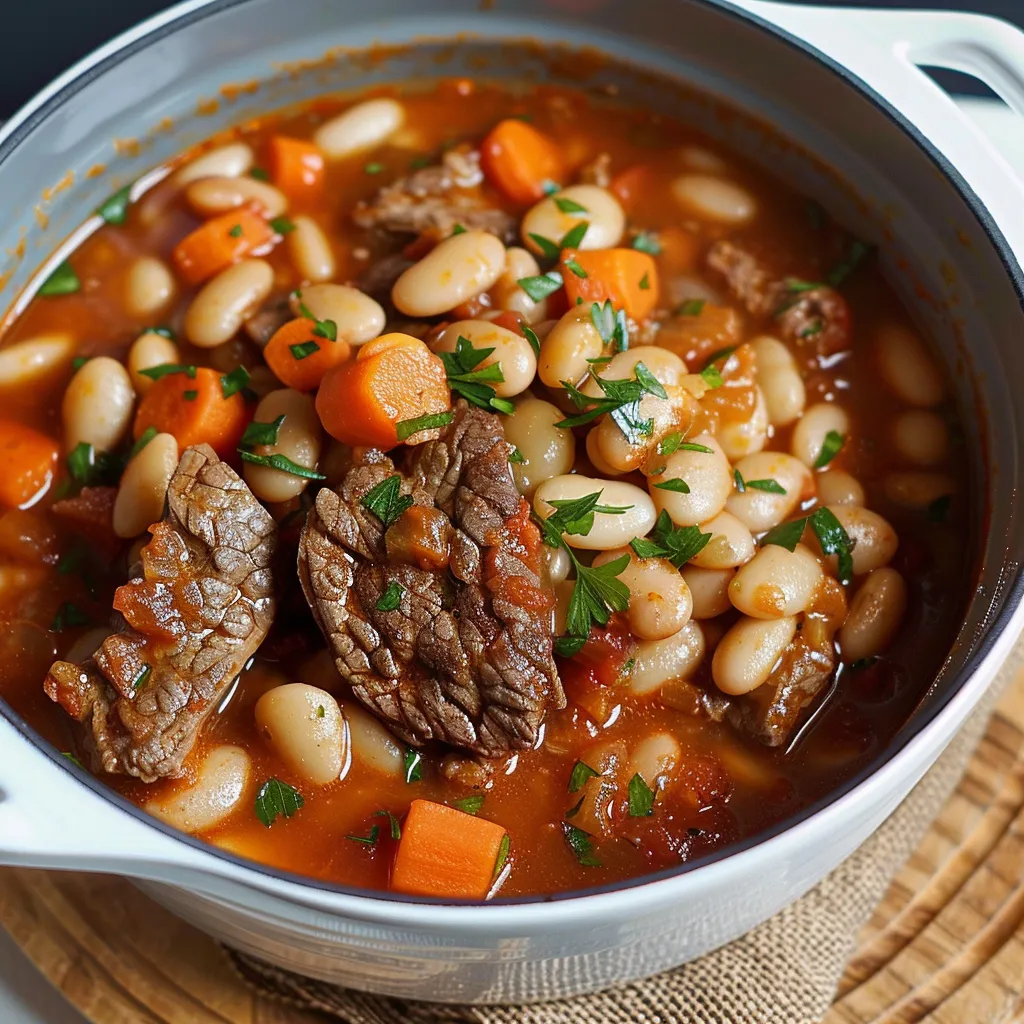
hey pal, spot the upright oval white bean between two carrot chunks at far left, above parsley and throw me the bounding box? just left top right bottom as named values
left=61, top=355, right=135, bottom=452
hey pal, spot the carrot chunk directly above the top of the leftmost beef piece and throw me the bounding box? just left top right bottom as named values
left=133, top=367, right=249, bottom=459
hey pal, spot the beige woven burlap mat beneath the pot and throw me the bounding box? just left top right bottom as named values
left=226, top=644, right=1024, bottom=1024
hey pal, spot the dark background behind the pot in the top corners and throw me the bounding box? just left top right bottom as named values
left=0, top=0, right=1024, bottom=119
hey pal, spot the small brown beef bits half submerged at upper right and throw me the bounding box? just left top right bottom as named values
left=707, top=240, right=853, bottom=355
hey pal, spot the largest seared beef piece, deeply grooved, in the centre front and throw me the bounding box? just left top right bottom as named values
left=299, top=402, right=565, bottom=756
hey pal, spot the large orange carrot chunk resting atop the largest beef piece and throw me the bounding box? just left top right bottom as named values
left=316, top=334, right=452, bottom=449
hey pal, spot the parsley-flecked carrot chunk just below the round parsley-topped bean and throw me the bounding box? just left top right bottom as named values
left=562, top=249, right=658, bottom=321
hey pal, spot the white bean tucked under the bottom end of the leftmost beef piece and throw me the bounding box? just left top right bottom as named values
left=145, top=745, right=252, bottom=834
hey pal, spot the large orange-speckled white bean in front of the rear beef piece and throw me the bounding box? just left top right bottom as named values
left=391, top=231, right=505, bottom=316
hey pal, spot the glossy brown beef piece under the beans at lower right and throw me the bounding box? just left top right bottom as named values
left=727, top=577, right=846, bottom=746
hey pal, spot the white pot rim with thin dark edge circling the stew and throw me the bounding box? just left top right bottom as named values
left=0, top=0, right=1024, bottom=931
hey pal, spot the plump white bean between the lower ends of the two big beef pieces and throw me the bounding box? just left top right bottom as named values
left=255, top=683, right=349, bottom=785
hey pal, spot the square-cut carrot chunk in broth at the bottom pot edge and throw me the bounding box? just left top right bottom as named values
left=391, top=800, right=506, bottom=899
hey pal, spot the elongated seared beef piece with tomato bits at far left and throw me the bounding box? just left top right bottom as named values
left=44, top=444, right=276, bottom=782
